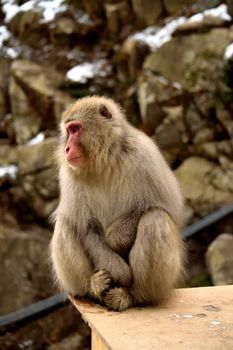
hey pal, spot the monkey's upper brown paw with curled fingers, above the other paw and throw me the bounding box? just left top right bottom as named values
left=91, top=270, right=112, bottom=300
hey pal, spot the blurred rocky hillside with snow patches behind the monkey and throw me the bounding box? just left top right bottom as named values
left=0, top=0, right=233, bottom=350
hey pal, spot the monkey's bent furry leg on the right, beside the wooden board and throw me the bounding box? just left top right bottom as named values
left=129, top=208, right=185, bottom=304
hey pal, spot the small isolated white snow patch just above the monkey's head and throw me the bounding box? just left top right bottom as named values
left=66, top=59, right=107, bottom=84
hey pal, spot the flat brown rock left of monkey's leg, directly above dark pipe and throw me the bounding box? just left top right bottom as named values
left=0, top=226, right=53, bottom=315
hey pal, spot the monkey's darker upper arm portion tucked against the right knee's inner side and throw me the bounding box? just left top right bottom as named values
left=105, top=210, right=142, bottom=257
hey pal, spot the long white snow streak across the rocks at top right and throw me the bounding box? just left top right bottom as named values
left=130, top=4, right=232, bottom=51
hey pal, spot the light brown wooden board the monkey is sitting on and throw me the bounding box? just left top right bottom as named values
left=72, top=286, right=233, bottom=350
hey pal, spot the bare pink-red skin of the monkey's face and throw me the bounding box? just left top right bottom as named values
left=65, top=120, right=86, bottom=166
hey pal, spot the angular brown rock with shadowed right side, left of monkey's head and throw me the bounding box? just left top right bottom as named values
left=9, top=60, right=61, bottom=144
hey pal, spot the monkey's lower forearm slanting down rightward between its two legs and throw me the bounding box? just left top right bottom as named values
left=82, top=219, right=132, bottom=287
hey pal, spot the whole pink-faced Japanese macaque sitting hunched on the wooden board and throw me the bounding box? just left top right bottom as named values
left=51, top=96, right=185, bottom=310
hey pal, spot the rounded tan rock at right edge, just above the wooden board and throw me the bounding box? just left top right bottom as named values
left=206, top=233, right=233, bottom=286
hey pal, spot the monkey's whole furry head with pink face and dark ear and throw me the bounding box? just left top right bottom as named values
left=59, top=96, right=127, bottom=173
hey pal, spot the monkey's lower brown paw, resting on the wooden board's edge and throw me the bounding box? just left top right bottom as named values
left=104, top=287, right=133, bottom=311
